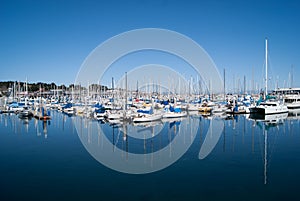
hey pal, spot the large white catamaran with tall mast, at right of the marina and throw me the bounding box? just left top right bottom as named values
left=249, top=39, right=288, bottom=115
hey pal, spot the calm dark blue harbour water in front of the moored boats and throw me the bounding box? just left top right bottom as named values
left=0, top=111, right=300, bottom=200
